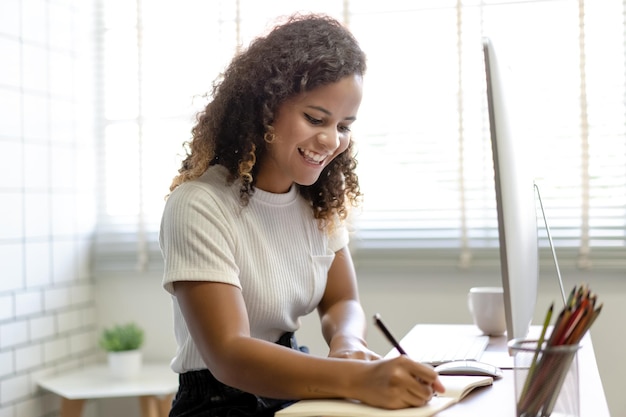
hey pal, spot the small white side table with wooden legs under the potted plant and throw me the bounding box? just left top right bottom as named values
left=37, top=364, right=178, bottom=417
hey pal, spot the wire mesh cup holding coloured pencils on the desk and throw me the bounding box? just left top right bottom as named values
left=509, top=339, right=580, bottom=417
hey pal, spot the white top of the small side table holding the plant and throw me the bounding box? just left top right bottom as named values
left=37, top=363, right=178, bottom=400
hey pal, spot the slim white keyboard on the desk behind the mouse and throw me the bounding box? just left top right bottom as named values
left=386, top=335, right=489, bottom=366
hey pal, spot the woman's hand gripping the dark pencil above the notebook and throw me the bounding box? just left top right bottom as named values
left=352, top=355, right=445, bottom=409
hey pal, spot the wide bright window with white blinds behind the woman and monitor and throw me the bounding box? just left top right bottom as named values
left=96, top=0, right=626, bottom=270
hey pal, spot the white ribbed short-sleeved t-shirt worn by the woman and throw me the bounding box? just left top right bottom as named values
left=159, top=165, right=348, bottom=373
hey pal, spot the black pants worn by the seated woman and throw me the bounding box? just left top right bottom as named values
left=169, top=333, right=307, bottom=417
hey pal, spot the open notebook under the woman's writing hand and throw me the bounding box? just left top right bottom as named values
left=276, top=375, right=493, bottom=417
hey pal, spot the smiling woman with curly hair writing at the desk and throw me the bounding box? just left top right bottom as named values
left=160, top=15, right=443, bottom=417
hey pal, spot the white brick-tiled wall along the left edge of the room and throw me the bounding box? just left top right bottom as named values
left=0, top=0, right=97, bottom=417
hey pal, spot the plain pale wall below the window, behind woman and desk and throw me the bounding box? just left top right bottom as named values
left=96, top=268, right=626, bottom=417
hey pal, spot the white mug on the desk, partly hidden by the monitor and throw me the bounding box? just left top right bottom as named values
left=467, top=287, right=506, bottom=336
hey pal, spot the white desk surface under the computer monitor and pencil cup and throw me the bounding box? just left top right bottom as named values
left=400, top=325, right=610, bottom=417
